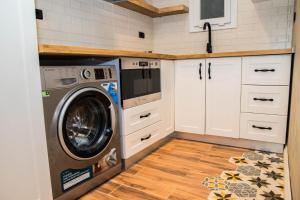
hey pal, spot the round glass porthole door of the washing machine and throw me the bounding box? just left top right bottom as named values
left=58, top=88, right=116, bottom=160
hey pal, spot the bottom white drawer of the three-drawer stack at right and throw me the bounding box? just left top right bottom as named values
left=240, top=113, right=287, bottom=144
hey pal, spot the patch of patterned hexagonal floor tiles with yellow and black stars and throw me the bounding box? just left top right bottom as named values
left=203, top=151, right=284, bottom=200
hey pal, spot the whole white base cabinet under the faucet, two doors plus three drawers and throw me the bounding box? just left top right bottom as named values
left=175, top=55, right=291, bottom=144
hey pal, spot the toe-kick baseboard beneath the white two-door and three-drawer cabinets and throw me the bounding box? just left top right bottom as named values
left=172, top=132, right=284, bottom=153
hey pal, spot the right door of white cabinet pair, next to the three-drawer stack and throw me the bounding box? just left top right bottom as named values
left=206, top=58, right=241, bottom=138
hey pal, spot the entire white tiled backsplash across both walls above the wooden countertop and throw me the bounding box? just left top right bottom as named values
left=36, top=0, right=294, bottom=54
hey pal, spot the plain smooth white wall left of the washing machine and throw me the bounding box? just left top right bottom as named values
left=0, top=0, right=52, bottom=200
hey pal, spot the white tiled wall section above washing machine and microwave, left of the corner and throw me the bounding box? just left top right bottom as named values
left=36, top=0, right=153, bottom=51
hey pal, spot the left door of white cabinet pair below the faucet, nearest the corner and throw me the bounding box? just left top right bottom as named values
left=175, top=60, right=205, bottom=134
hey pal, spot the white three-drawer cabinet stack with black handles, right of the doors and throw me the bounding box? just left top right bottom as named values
left=240, top=55, right=291, bottom=144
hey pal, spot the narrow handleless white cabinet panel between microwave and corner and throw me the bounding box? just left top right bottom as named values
left=160, top=60, right=175, bottom=136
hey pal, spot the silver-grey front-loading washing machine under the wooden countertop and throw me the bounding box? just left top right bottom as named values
left=40, top=58, right=121, bottom=200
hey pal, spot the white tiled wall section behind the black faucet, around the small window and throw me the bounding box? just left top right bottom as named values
left=152, top=0, right=294, bottom=54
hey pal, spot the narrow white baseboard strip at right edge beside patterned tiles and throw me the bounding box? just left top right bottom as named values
left=283, top=146, right=292, bottom=200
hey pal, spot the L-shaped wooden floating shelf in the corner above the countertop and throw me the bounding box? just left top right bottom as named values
left=115, top=0, right=189, bottom=18
